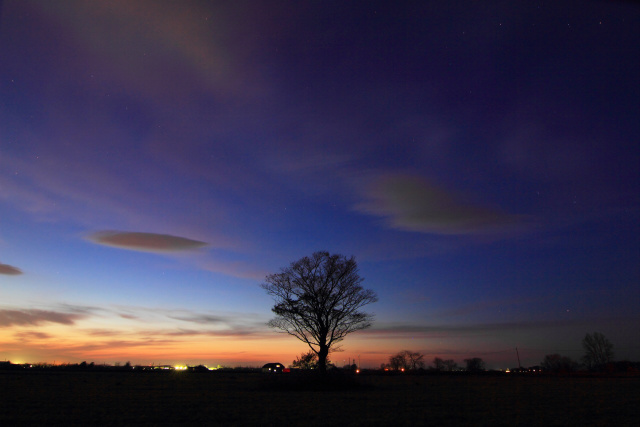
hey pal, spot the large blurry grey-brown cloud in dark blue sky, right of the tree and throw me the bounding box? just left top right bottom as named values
left=356, top=175, right=520, bottom=234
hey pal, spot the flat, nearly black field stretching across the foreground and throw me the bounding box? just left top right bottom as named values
left=0, top=371, right=640, bottom=426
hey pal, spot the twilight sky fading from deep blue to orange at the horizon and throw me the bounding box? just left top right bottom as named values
left=0, top=0, right=640, bottom=368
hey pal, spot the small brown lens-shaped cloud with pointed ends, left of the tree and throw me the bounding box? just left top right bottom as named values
left=87, top=231, right=207, bottom=252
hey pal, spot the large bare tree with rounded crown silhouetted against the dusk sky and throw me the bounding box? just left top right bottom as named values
left=262, top=252, right=378, bottom=373
